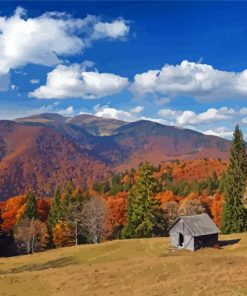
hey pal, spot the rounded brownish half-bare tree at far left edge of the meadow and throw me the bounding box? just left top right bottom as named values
left=14, top=219, right=49, bottom=254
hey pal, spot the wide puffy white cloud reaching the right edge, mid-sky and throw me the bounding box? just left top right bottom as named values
left=131, top=60, right=247, bottom=101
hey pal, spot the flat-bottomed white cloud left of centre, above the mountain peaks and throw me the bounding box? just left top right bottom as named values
left=29, top=64, right=128, bottom=99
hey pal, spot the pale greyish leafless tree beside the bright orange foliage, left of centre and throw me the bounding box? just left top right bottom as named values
left=79, top=197, right=107, bottom=244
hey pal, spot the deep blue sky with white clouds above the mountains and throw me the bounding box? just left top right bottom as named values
left=0, top=1, right=247, bottom=138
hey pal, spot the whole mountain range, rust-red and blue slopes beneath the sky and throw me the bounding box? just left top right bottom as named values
left=0, top=113, right=230, bottom=200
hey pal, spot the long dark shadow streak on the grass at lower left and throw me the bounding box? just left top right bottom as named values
left=0, top=257, right=79, bottom=275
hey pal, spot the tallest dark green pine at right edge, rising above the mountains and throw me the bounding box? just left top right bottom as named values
left=221, top=125, right=247, bottom=234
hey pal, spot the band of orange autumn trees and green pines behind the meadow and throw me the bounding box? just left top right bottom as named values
left=0, top=121, right=247, bottom=256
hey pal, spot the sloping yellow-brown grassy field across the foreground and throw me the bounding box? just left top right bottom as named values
left=0, top=234, right=247, bottom=296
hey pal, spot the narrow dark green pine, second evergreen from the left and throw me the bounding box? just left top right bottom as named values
left=47, top=187, right=64, bottom=233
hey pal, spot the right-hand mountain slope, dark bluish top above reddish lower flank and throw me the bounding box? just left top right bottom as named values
left=110, top=120, right=229, bottom=170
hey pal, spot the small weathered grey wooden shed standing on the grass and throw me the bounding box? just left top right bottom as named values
left=169, top=214, right=220, bottom=251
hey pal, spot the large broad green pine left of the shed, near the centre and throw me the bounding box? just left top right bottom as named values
left=123, top=162, right=164, bottom=238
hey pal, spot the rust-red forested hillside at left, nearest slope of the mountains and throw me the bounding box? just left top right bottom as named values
left=0, top=121, right=107, bottom=199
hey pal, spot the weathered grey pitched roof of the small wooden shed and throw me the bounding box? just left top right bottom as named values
left=169, top=214, right=220, bottom=236
